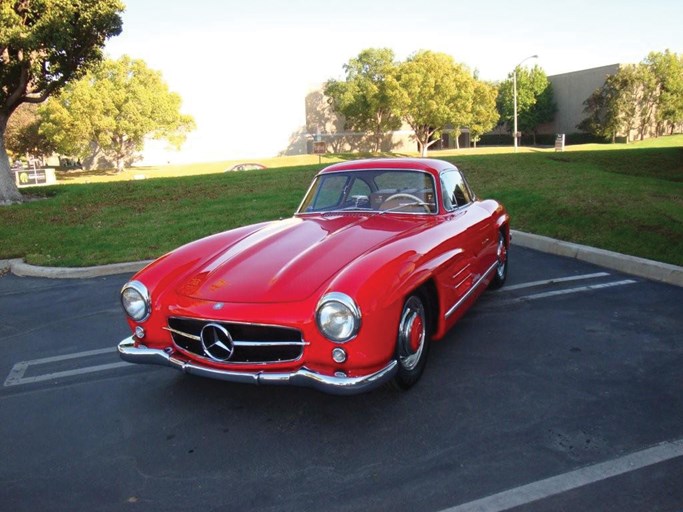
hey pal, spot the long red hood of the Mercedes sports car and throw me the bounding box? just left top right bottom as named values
left=176, top=215, right=423, bottom=303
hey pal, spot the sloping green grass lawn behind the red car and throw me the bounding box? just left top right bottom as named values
left=0, top=135, right=683, bottom=266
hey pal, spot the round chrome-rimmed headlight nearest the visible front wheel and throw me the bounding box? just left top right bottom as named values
left=316, top=292, right=360, bottom=343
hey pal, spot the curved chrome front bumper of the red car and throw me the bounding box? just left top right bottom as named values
left=118, top=336, right=398, bottom=395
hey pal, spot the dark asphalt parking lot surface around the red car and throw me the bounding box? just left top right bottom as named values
left=0, top=247, right=683, bottom=512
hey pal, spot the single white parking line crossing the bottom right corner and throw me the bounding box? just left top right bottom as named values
left=441, top=439, right=683, bottom=512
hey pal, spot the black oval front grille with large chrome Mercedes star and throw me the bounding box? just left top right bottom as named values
left=166, top=317, right=306, bottom=364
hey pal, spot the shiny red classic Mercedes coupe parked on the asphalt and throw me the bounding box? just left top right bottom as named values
left=119, top=158, right=510, bottom=394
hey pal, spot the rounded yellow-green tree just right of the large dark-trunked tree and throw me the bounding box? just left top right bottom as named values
left=39, top=55, right=194, bottom=172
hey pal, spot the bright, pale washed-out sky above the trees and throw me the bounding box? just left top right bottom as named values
left=105, top=0, right=683, bottom=164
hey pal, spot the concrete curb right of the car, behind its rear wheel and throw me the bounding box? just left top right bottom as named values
left=511, top=230, right=683, bottom=287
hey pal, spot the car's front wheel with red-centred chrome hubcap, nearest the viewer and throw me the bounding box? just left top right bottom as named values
left=394, top=294, right=429, bottom=389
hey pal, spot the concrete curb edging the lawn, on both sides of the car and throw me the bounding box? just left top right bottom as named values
left=0, top=230, right=683, bottom=287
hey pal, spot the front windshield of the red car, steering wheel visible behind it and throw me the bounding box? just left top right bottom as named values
left=297, top=170, right=437, bottom=214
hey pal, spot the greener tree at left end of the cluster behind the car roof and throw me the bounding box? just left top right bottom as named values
left=324, top=48, right=401, bottom=152
